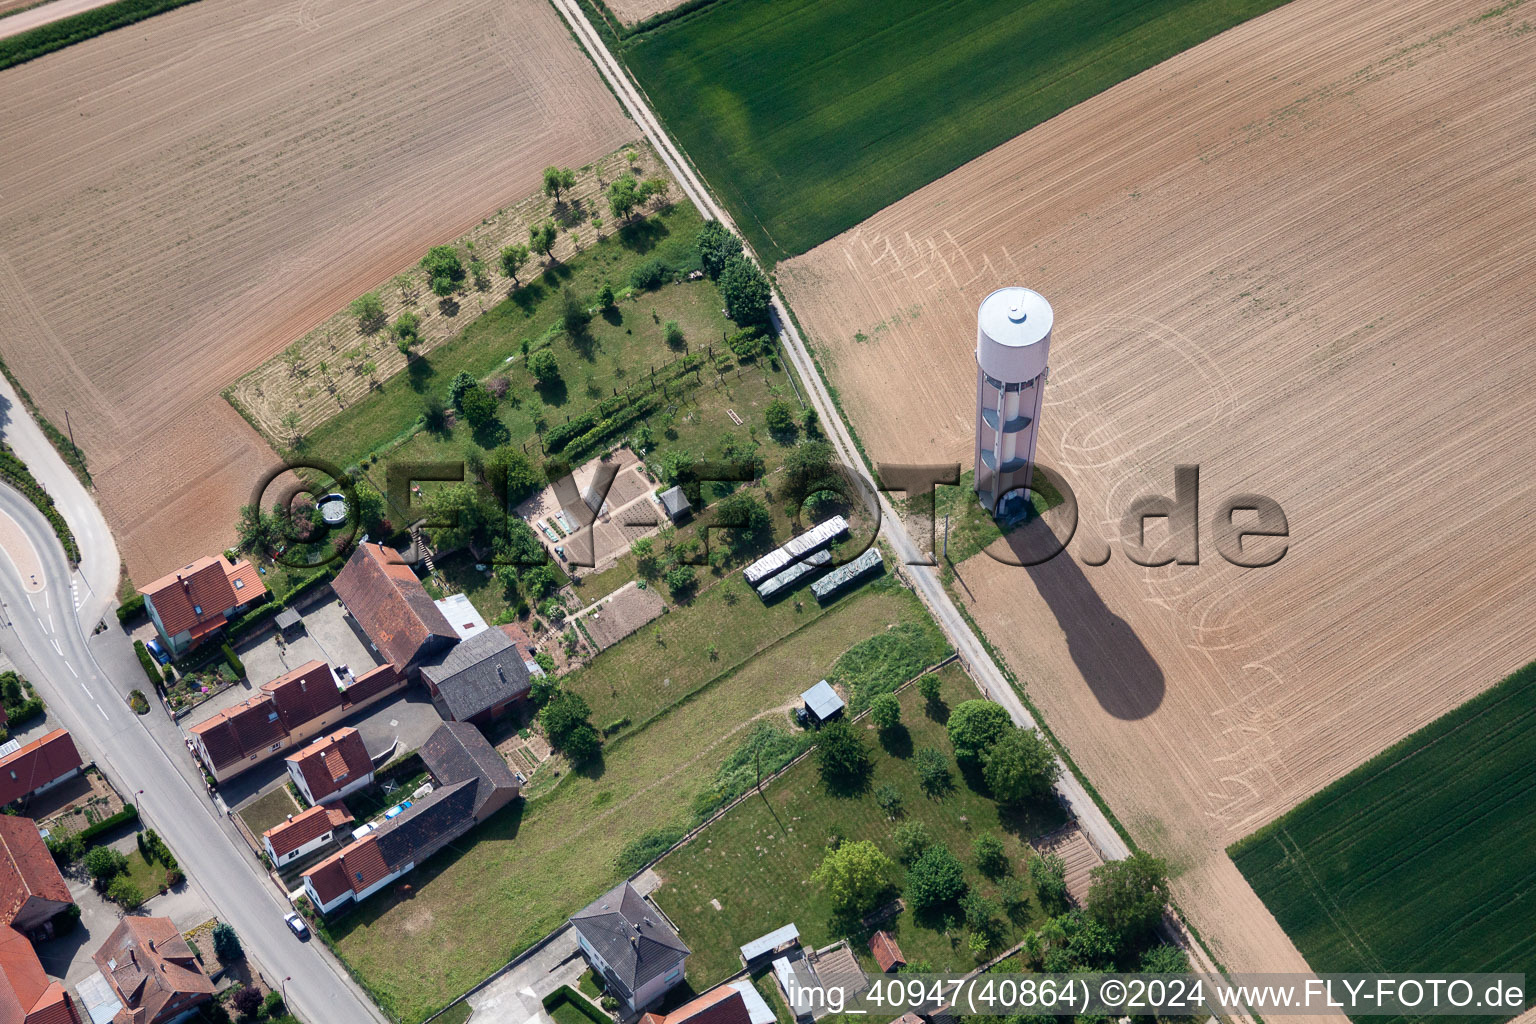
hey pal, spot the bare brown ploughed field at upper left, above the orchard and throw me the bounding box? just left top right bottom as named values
left=0, top=0, right=633, bottom=580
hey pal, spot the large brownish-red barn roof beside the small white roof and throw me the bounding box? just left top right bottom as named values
left=332, top=543, right=458, bottom=671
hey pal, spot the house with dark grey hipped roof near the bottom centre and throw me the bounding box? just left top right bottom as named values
left=570, top=881, right=691, bottom=1015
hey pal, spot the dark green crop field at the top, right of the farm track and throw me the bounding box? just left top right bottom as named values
left=622, top=0, right=1283, bottom=263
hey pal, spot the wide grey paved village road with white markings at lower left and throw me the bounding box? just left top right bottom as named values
left=0, top=500, right=384, bottom=1024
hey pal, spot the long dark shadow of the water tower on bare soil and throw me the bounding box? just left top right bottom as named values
left=994, top=517, right=1166, bottom=722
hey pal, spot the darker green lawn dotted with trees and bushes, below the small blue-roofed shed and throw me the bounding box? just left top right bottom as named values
left=656, top=665, right=1063, bottom=992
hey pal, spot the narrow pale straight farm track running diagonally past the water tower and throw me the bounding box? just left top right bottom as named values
left=553, top=0, right=1130, bottom=858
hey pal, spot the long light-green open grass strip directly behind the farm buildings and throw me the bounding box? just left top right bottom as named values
left=329, top=583, right=925, bottom=1021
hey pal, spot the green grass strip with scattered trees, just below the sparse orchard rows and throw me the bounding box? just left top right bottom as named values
left=304, top=203, right=734, bottom=467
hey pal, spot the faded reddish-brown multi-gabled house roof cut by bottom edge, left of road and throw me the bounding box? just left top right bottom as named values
left=91, top=918, right=214, bottom=1024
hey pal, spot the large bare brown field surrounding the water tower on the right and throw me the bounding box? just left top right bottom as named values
left=777, top=0, right=1536, bottom=994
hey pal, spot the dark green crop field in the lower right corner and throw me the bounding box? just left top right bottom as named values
left=1229, top=663, right=1536, bottom=1019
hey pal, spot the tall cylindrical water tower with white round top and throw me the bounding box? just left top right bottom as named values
left=975, top=286, right=1054, bottom=517
